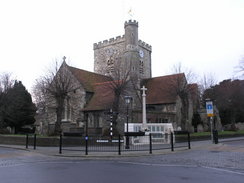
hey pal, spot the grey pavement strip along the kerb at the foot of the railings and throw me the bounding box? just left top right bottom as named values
left=0, top=137, right=244, bottom=158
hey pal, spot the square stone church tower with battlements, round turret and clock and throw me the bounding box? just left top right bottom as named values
left=93, top=20, right=152, bottom=80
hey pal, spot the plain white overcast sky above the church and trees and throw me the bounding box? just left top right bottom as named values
left=0, top=0, right=244, bottom=90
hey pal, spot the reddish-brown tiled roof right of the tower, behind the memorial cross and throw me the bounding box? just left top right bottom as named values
left=142, top=73, right=185, bottom=104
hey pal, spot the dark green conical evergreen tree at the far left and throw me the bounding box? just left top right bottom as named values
left=3, top=81, right=36, bottom=133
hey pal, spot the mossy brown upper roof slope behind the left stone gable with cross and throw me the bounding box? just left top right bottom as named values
left=68, top=66, right=111, bottom=92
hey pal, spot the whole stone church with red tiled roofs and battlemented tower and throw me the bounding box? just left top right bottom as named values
left=38, top=20, right=198, bottom=135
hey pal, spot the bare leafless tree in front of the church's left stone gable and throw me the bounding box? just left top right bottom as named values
left=34, top=57, right=80, bottom=134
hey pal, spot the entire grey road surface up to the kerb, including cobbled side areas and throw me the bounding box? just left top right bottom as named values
left=0, top=141, right=244, bottom=183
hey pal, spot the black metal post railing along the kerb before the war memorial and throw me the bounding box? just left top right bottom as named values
left=59, top=132, right=191, bottom=155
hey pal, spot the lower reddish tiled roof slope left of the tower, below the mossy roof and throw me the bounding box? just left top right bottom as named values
left=83, top=81, right=114, bottom=111
